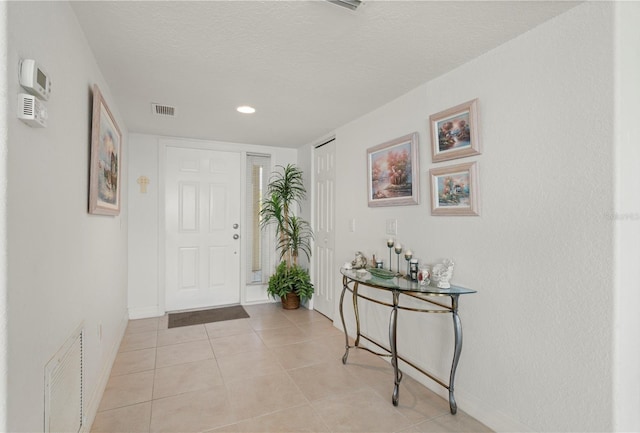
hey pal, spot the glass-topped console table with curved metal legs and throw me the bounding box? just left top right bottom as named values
left=340, top=268, right=476, bottom=414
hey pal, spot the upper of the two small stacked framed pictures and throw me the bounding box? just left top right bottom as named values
left=429, top=99, right=480, bottom=162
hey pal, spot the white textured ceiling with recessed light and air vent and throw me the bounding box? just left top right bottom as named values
left=71, top=0, right=576, bottom=147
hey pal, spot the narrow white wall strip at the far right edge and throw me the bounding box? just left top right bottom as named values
left=612, top=2, right=640, bottom=431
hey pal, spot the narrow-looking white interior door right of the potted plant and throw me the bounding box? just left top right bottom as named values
left=313, top=141, right=338, bottom=319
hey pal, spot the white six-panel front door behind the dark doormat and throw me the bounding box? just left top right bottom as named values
left=165, top=147, right=241, bottom=311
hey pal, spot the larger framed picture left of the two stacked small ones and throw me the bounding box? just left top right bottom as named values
left=367, top=132, right=420, bottom=207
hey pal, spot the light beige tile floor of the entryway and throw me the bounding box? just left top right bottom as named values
left=91, top=304, right=490, bottom=433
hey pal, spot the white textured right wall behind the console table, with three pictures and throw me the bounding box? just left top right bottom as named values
left=336, top=2, right=616, bottom=431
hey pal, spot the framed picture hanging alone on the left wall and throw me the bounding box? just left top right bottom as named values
left=89, top=85, right=122, bottom=215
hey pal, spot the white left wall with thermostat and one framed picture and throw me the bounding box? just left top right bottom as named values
left=0, top=2, right=127, bottom=432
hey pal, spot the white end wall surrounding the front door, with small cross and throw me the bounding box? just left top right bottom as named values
left=128, top=134, right=297, bottom=319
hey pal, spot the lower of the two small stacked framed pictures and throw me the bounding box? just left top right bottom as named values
left=429, top=162, right=480, bottom=215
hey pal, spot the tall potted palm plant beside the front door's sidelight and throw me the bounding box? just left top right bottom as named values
left=260, top=164, right=314, bottom=309
